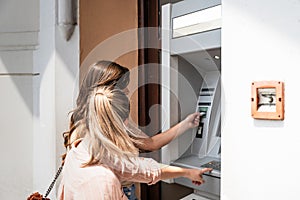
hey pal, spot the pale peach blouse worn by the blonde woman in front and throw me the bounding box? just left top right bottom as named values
left=58, top=140, right=161, bottom=200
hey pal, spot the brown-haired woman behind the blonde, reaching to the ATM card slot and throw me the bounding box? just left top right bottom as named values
left=63, top=60, right=211, bottom=199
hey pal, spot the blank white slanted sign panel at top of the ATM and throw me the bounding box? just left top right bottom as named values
left=172, top=5, right=221, bottom=38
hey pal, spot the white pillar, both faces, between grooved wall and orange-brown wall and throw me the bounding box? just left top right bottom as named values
left=33, top=1, right=79, bottom=199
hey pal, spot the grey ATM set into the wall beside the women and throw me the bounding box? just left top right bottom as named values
left=161, top=0, right=221, bottom=200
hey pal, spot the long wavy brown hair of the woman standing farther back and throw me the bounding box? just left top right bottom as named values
left=62, top=60, right=130, bottom=163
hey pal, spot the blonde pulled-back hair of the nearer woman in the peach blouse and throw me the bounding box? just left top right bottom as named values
left=87, top=86, right=138, bottom=165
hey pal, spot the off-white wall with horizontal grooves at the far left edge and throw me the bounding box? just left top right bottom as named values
left=0, top=0, right=39, bottom=200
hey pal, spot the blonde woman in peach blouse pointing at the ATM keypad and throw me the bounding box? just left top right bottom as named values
left=59, top=86, right=212, bottom=200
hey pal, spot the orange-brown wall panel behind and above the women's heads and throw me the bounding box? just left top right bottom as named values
left=79, top=0, right=138, bottom=121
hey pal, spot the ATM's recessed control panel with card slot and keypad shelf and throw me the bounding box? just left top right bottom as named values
left=171, top=71, right=221, bottom=198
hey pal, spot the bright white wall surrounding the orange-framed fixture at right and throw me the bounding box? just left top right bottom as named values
left=221, top=0, right=300, bottom=200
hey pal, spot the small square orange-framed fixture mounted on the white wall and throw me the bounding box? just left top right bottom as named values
left=251, top=81, right=284, bottom=120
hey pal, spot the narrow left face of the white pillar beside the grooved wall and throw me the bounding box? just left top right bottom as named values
left=32, top=1, right=56, bottom=198
